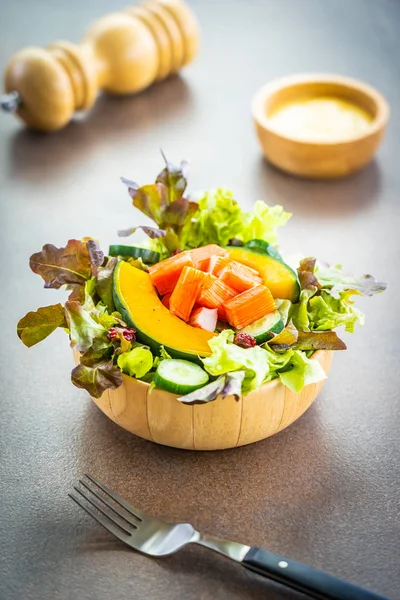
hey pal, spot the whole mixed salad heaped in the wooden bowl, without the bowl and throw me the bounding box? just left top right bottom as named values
left=17, top=157, right=386, bottom=404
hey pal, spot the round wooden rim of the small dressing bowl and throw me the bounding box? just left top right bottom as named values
left=251, top=73, right=390, bottom=147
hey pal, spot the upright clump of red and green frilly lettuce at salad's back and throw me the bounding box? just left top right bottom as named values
left=119, top=155, right=291, bottom=258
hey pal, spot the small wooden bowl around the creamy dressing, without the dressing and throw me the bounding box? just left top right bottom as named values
left=252, top=75, right=389, bottom=179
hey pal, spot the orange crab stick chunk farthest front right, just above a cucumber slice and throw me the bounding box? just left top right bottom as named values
left=225, top=285, right=276, bottom=329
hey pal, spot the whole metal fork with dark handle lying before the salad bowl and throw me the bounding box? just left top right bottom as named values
left=68, top=474, right=388, bottom=600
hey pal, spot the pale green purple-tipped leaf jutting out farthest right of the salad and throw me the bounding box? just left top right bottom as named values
left=316, top=263, right=387, bottom=299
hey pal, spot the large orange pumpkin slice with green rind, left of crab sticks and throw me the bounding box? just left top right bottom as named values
left=113, top=261, right=216, bottom=364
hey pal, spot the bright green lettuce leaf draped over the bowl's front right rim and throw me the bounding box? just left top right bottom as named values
left=279, top=350, right=326, bottom=392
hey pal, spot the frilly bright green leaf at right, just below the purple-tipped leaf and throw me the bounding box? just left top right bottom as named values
left=308, top=290, right=365, bottom=333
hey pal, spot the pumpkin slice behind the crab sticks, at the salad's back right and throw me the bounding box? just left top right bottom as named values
left=227, top=246, right=300, bottom=302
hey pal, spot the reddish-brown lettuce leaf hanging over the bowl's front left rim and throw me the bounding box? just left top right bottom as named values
left=71, top=360, right=122, bottom=398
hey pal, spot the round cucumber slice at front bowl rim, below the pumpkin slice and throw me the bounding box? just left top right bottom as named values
left=154, top=358, right=208, bottom=395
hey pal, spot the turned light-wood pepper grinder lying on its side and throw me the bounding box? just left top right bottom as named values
left=0, top=0, right=199, bottom=131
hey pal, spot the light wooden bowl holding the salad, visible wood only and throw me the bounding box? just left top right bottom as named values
left=83, top=350, right=332, bottom=450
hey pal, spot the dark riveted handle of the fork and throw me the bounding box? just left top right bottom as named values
left=242, top=547, right=388, bottom=600
